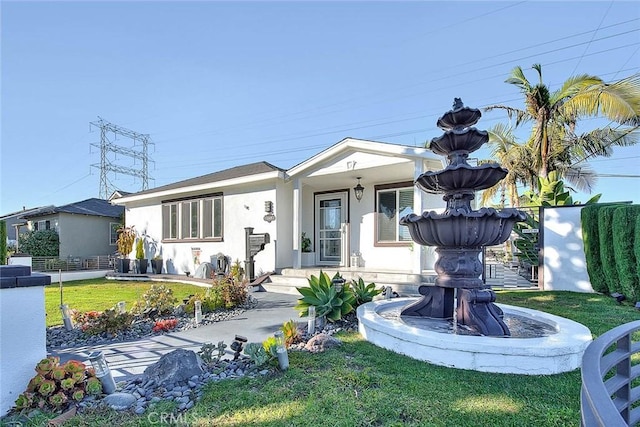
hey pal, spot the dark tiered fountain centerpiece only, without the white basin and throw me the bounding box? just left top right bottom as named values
left=400, top=98, right=526, bottom=336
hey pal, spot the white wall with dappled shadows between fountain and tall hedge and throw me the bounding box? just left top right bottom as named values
left=543, top=206, right=593, bottom=292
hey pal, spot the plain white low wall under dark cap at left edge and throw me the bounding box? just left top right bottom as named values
left=0, top=286, right=47, bottom=416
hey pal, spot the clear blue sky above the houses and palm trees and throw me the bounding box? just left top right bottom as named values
left=0, top=1, right=640, bottom=214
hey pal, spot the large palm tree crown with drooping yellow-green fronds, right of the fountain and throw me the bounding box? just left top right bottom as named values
left=486, top=64, right=640, bottom=191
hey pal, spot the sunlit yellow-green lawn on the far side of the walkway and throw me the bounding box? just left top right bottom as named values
left=44, top=279, right=210, bottom=326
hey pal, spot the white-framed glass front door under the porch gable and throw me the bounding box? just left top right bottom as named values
left=315, top=192, right=347, bottom=266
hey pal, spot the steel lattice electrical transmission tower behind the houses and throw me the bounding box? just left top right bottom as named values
left=89, top=116, right=153, bottom=200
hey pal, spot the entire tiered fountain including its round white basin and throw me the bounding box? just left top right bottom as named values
left=358, top=98, right=591, bottom=375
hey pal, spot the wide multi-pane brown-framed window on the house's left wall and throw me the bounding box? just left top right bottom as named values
left=162, top=195, right=222, bottom=240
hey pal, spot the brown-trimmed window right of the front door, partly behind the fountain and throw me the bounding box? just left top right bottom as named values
left=376, top=183, right=413, bottom=245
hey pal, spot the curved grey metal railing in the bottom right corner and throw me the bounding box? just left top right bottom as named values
left=580, top=320, right=640, bottom=427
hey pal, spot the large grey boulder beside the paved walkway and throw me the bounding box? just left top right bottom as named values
left=143, top=348, right=204, bottom=385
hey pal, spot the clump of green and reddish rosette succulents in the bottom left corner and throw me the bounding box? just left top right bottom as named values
left=15, top=356, right=102, bottom=412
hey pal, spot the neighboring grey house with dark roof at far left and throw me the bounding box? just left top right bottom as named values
left=22, top=198, right=124, bottom=258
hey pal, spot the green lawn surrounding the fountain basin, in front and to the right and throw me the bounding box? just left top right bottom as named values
left=8, top=291, right=640, bottom=426
